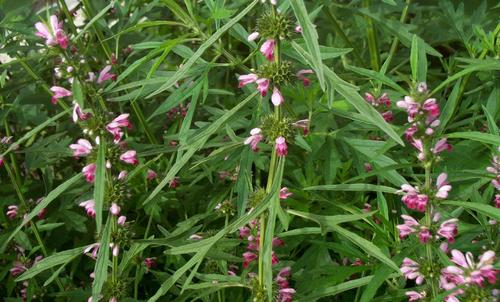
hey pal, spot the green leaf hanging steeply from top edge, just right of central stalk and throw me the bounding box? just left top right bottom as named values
left=290, top=0, right=326, bottom=90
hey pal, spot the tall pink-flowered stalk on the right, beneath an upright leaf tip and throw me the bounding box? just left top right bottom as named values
left=397, top=83, right=456, bottom=299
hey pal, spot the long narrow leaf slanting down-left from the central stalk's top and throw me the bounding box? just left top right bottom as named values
left=147, top=0, right=258, bottom=98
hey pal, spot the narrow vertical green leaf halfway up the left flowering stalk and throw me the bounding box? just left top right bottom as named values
left=94, top=139, right=106, bottom=233
